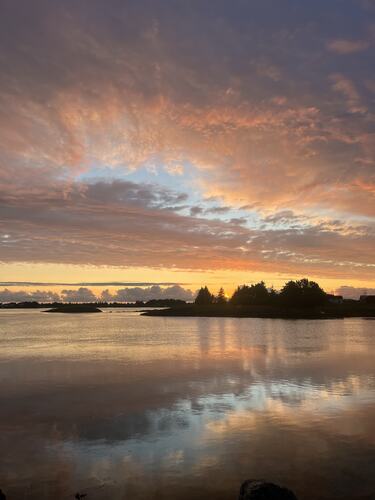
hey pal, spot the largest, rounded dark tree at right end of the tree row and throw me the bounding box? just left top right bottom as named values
left=279, top=278, right=327, bottom=307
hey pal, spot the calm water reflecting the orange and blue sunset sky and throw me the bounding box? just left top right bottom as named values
left=0, top=310, right=375, bottom=500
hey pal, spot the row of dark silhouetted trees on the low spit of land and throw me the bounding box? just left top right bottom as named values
left=195, top=278, right=328, bottom=308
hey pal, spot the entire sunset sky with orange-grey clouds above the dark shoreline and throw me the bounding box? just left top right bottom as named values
left=0, top=0, right=375, bottom=300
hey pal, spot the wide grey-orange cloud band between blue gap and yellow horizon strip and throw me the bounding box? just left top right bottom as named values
left=0, top=177, right=375, bottom=277
